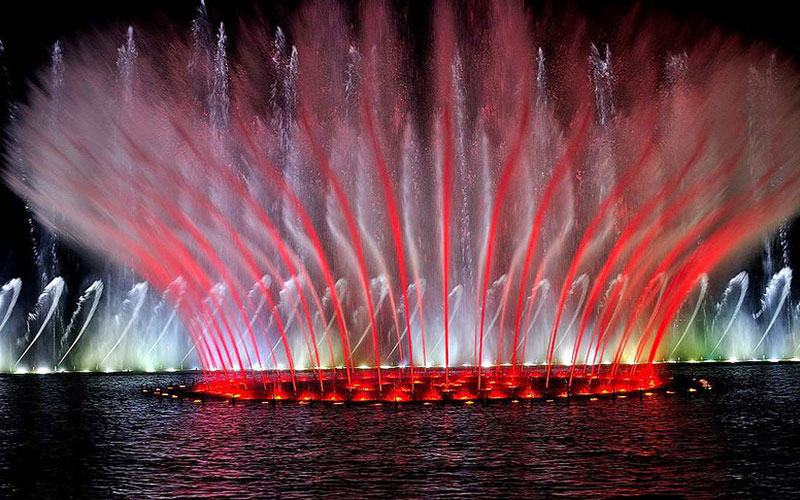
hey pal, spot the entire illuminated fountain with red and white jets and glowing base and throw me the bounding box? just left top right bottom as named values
left=0, top=2, right=800, bottom=402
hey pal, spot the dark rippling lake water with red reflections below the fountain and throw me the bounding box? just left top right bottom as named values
left=0, top=363, right=800, bottom=499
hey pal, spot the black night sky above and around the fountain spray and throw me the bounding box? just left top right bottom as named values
left=0, top=0, right=800, bottom=302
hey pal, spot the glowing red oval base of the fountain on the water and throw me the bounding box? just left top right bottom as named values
left=190, top=365, right=666, bottom=403
